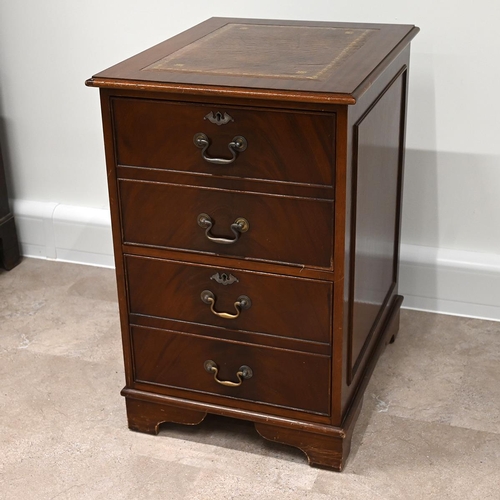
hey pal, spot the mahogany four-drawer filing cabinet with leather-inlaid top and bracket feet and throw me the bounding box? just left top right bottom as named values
left=87, top=18, right=418, bottom=470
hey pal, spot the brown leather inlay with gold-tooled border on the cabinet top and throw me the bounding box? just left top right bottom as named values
left=143, top=23, right=378, bottom=80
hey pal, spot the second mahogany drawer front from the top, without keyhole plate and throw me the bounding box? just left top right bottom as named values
left=119, top=179, right=333, bottom=268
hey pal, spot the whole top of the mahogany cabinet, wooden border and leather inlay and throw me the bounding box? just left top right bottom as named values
left=88, top=18, right=418, bottom=101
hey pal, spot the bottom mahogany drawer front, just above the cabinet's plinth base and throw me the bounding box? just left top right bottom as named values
left=131, top=327, right=331, bottom=415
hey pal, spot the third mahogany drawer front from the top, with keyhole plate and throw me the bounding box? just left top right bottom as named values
left=125, top=255, right=333, bottom=344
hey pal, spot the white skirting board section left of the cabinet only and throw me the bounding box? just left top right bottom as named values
left=11, top=200, right=114, bottom=268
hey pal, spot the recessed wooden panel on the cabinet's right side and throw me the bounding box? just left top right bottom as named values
left=347, top=69, right=406, bottom=383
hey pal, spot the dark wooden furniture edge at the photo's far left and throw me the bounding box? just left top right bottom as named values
left=0, top=139, right=21, bottom=270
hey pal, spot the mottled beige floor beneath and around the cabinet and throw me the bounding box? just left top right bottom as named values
left=0, top=259, right=500, bottom=500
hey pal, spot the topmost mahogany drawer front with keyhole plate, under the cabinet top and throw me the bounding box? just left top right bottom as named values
left=112, top=98, right=335, bottom=186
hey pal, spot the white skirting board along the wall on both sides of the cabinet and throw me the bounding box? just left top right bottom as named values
left=12, top=200, right=500, bottom=321
